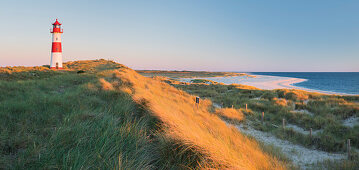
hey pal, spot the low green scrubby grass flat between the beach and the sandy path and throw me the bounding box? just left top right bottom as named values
left=162, top=80, right=359, bottom=169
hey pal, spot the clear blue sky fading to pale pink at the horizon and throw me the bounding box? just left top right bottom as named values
left=0, top=0, right=359, bottom=72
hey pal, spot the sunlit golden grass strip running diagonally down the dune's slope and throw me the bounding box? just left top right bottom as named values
left=105, top=68, right=285, bottom=169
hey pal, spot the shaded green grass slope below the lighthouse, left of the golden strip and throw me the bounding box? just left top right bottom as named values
left=0, top=60, right=210, bottom=169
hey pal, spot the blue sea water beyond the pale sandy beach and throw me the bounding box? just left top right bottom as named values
left=249, top=72, right=359, bottom=95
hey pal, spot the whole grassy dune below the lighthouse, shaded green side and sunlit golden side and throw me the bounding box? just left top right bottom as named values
left=0, top=60, right=285, bottom=169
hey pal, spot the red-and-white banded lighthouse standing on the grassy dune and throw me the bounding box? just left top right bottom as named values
left=50, top=19, right=63, bottom=69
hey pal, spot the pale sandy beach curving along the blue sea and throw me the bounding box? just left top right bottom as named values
left=180, top=74, right=357, bottom=95
